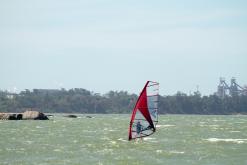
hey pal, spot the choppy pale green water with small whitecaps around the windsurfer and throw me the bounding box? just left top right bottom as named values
left=0, top=115, right=247, bottom=165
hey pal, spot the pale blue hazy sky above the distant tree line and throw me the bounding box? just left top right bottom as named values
left=0, top=0, right=247, bottom=95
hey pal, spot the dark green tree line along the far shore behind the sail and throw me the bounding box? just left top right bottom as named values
left=0, top=88, right=247, bottom=115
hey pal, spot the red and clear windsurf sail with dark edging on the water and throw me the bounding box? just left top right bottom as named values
left=129, top=81, right=159, bottom=140
